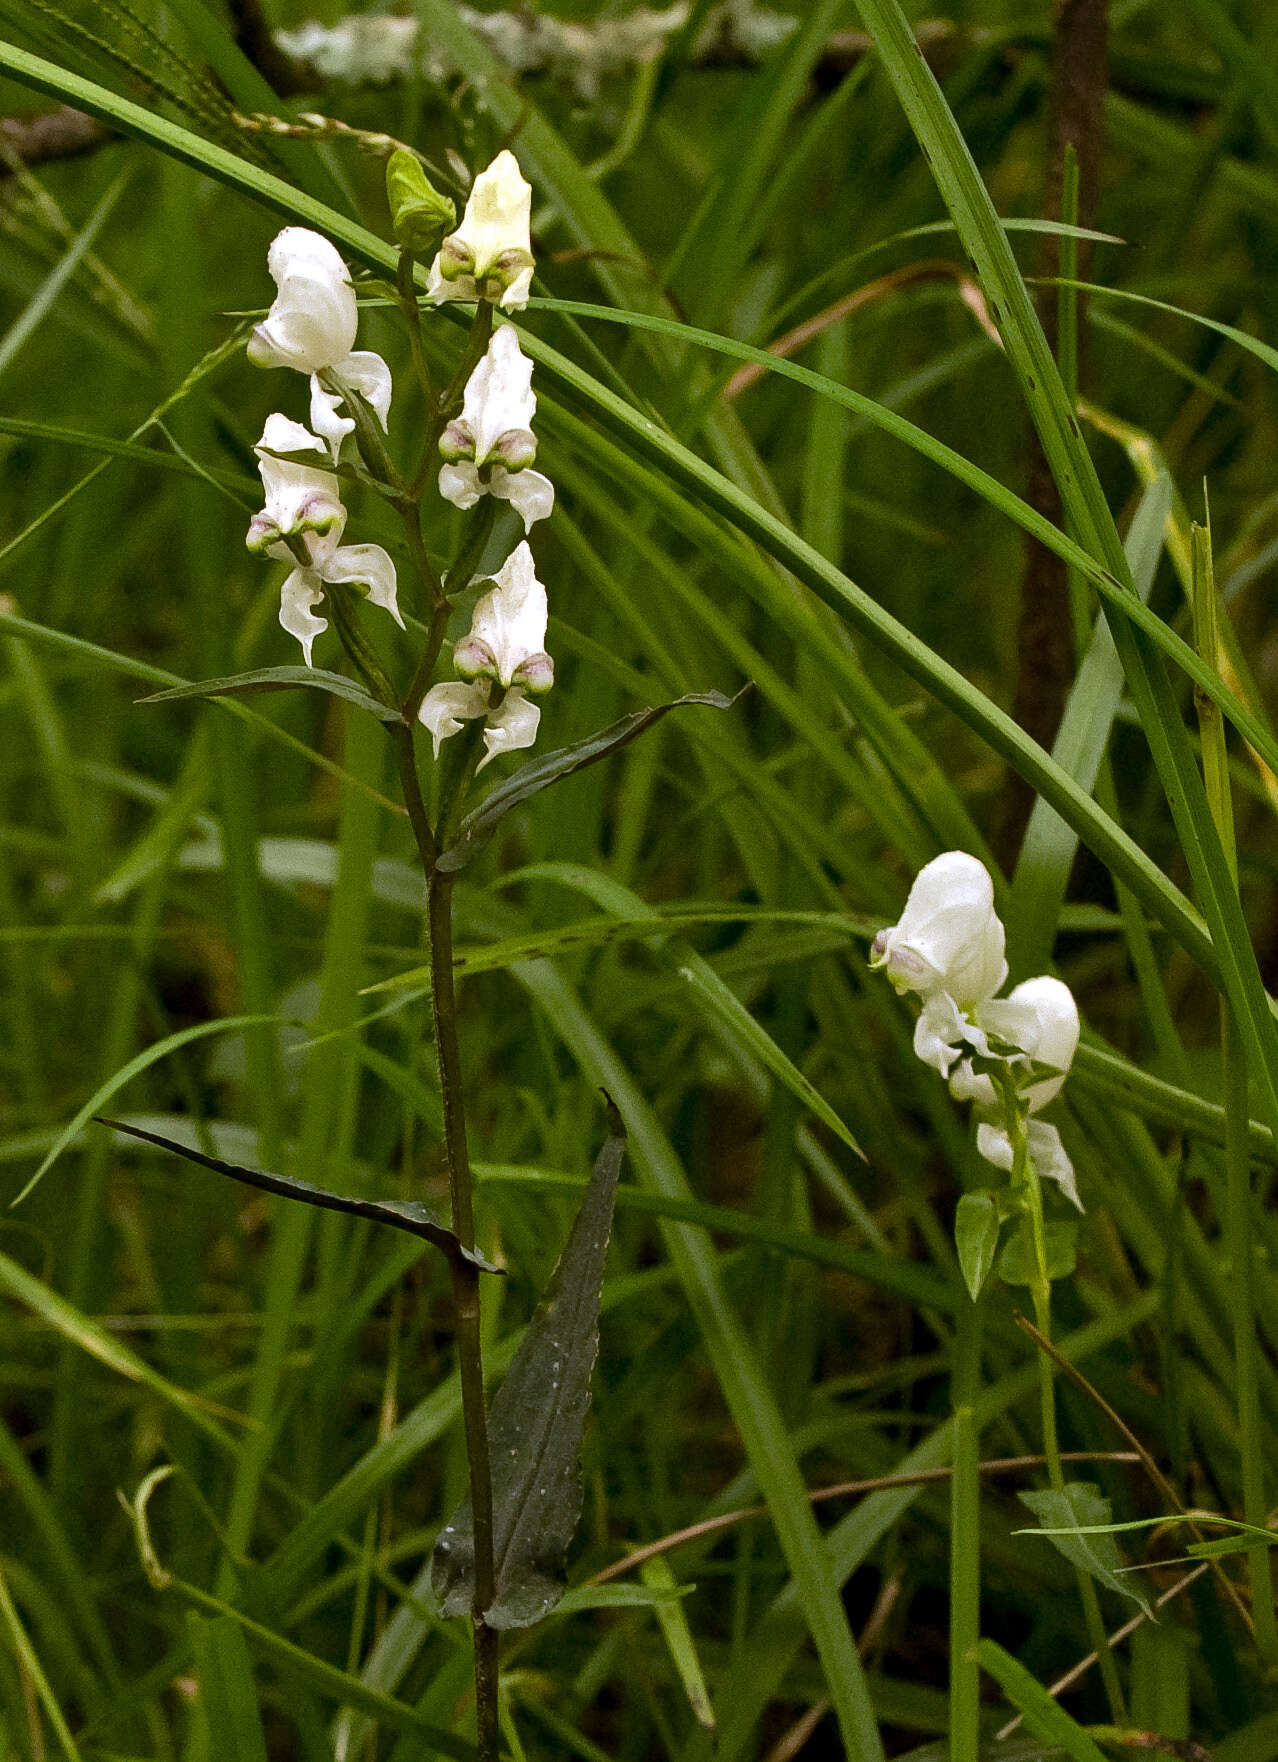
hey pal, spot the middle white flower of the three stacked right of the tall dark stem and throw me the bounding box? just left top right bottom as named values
left=439, top=324, right=555, bottom=532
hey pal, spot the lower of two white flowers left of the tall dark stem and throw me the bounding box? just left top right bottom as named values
left=247, top=414, right=404, bottom=666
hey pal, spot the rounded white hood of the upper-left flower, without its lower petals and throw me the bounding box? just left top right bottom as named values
left=249, top=226, right=358, bottom=374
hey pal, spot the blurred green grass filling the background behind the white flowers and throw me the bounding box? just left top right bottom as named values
left=0, top=0, right=1278, bottom=1762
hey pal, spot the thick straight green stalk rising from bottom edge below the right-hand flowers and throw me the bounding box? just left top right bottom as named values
left=950, top=1288, right=984, bottom=1762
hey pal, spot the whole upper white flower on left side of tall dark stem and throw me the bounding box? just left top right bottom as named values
left=249, top=226, right=391, bottom=458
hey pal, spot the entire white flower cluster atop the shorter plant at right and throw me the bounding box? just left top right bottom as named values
left=869, top=851, right=1082, bottom=1210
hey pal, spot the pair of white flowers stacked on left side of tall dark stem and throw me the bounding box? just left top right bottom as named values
left=245, top=226, right=393, bottom=666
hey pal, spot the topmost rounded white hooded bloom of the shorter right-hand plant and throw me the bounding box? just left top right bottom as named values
left=869, top=851, right=1007, bottom=1011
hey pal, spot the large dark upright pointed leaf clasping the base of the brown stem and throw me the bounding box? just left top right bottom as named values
left=430, top=1101, right=626, bottom=1628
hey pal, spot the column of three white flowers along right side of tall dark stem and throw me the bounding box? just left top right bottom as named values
left=418, top=153, right=555, bottom=770
